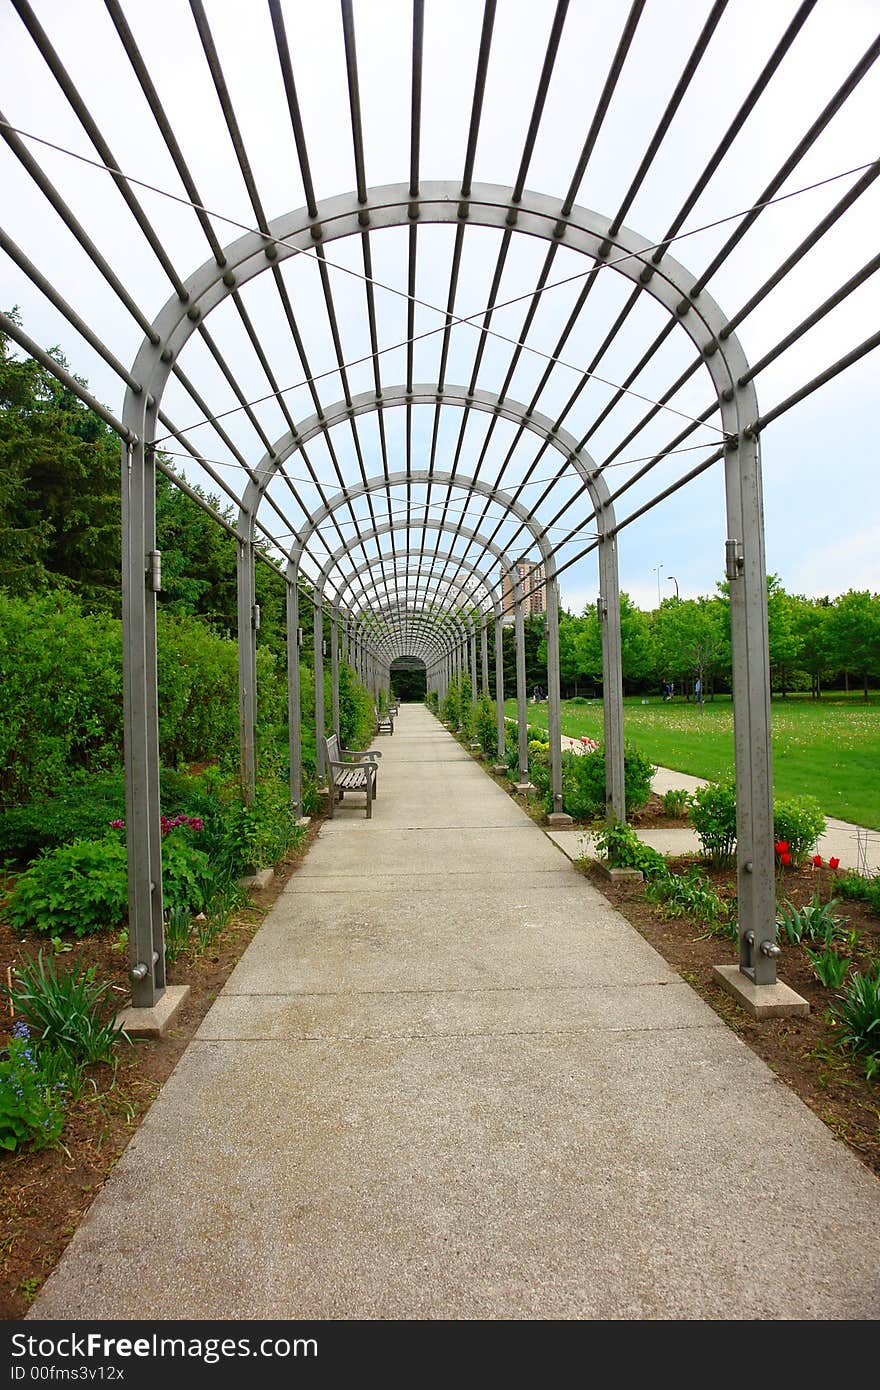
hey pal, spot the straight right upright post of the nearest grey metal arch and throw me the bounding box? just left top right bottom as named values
left=724, top=430, right=776, bottom=984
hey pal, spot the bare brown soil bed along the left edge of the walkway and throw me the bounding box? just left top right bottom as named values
left=0, top=817, right=321, bottom=1319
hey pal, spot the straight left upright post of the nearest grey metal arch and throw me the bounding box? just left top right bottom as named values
left=122, top=428, right=165, bottom=1008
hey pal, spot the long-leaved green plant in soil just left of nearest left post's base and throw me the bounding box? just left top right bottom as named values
left=10, top=951, right=128, bottom=1065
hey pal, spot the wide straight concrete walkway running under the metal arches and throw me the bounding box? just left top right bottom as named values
left=32, top=706, right=880, bottom=1321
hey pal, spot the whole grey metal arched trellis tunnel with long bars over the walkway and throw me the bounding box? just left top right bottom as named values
left=0, top=0, right=880, bottom=1023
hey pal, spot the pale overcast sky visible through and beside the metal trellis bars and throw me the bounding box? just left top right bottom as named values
left=0, top=0, right=880, bottom=609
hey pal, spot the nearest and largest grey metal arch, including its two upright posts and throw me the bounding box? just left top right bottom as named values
left=122, top=182, right=776, bottom=1006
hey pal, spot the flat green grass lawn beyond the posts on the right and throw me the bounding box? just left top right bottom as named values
left=505, top=695, right=880, bottom=828
